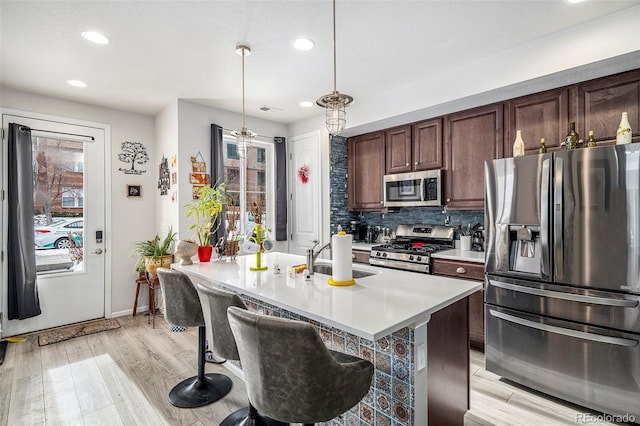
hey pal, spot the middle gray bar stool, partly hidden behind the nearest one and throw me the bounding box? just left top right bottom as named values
left=196, top=283, right=287, bottom=426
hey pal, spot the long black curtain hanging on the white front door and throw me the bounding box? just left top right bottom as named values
left=7, top=123, right=41, bottom=320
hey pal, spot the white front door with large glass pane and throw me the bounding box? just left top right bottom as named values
left=0, top=114, right=106, bottom=337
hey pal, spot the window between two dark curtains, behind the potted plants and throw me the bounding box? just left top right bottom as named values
left=224, top=134, right=275, bottom=233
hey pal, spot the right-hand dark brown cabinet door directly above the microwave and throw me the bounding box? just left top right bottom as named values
left=413, top=118, right=442, bottom=171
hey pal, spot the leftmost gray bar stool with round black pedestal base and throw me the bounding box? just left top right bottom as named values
left=158, top=268, right=232, bottom=408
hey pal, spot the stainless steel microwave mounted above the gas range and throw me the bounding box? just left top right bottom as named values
left=384, top=170, right=442, bottom=207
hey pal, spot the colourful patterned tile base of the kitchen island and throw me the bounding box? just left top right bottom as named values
left=242, top=296, right=415, bottom=426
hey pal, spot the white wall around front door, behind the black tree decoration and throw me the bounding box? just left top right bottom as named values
left=0, top=88, right=157, bottom=315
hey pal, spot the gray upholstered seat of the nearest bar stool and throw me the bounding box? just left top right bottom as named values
left=228, top=307, right=373, bottom=424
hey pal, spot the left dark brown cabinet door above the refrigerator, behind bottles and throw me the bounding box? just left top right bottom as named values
left=504, top=88, right=575, bottom=157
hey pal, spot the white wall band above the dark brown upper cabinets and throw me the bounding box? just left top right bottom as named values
left=338, top=6, right=640, bottom=136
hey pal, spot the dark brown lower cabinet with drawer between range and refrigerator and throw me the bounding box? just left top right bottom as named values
left=433, top=259, right=484, bottom=352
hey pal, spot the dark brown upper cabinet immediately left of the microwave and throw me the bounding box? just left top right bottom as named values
left=347, top=131, right=385, bottom=211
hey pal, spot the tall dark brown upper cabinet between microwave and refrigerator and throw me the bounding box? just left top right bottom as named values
left=444, top=104, right=504, bottom=210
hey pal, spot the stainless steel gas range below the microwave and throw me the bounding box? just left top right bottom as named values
left=369, top=225, right=455, bottom=274
